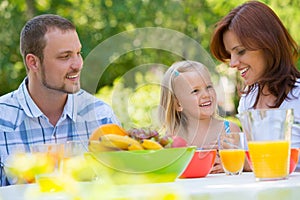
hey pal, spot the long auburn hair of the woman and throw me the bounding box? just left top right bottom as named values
left=210, top=1, right=300, bottom=108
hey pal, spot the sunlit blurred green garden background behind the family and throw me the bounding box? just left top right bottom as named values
left=0, top=0, right=300, bottom=129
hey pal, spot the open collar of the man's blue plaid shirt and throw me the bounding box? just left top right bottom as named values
left=16, top=77, right=77, bottom=122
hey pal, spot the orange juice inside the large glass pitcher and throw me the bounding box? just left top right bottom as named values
left=248, top=141, right=290, bottom=179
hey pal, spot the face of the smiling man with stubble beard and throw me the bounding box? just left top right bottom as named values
left=39, top=28, right=83, bottom=93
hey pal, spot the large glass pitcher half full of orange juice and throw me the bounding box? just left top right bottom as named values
left=239, top=109, right=294, bottom=181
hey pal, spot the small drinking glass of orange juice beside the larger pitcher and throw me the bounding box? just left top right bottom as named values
left=218, top=132, right=246, bottom=175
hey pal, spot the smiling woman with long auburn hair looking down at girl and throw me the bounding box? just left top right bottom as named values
left=210, top=1, right=300, bottom=169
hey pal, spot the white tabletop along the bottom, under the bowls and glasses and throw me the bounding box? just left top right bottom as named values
left=0, top=172, right=300, bottom=200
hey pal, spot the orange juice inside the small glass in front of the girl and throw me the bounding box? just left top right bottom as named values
left=219, top=149, right=245, bottom=173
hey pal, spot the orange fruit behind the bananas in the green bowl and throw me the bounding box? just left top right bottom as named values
left=90, top=124, right=128, bottom=141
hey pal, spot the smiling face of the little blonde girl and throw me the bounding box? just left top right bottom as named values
left=174, top=70, right=216, bottom=119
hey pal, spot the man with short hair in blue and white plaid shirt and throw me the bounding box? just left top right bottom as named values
left=0, top=14, right=119, bottom=186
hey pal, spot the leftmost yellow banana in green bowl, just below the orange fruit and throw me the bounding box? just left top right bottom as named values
left=99, top=134, right=139, bottom=150
